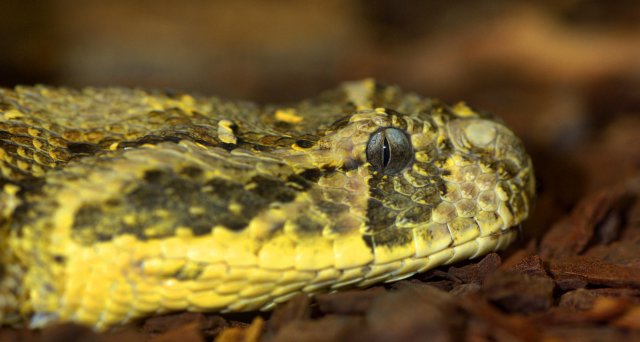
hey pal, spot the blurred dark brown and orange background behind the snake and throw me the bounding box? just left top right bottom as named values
left=0, top=0, right=640, bottom=238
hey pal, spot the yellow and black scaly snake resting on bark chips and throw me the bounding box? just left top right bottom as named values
left=0, top=79, right=535, bottom=331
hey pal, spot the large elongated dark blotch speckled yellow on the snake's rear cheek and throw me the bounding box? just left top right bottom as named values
left=73, top=168, right=299, bottom=245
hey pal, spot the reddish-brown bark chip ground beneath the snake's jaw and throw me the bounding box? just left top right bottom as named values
left=0, top=178, right=640, bottom=342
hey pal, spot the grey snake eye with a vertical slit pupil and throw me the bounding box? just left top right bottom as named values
left=367, top=127, right=413, bottom=175
